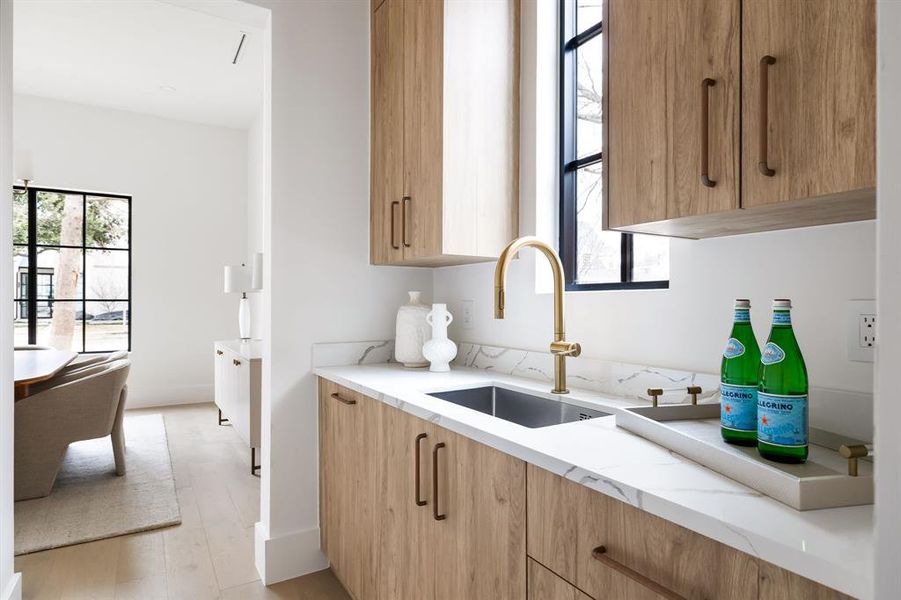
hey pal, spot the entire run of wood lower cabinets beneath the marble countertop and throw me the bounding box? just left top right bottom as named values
left=319, top=380, right=849, bottom=600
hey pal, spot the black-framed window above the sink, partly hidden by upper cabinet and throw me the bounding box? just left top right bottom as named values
left=559, top=0, right=669, bottom=290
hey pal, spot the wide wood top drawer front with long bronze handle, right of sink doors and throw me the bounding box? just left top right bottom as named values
left=527, top=465, right=758, bottom=600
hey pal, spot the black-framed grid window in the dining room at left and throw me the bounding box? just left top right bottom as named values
left=13, top=187, right=132, bottom=353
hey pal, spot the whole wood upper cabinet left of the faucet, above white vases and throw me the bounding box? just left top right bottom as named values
left=370, top=0, right=519, bottom=266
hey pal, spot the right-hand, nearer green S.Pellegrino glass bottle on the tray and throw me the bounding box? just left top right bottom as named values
left=757, top=300, right=808, bottom=463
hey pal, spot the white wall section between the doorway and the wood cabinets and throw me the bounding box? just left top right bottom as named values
left=244, top=0, right=432, bottom=583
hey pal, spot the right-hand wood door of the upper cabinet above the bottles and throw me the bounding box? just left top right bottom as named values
left=742, top=0, right=876, bottom=207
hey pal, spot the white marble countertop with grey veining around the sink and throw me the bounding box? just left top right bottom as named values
left=315, top=364, right=873, bottom=599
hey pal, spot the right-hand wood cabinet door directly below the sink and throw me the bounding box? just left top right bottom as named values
left=431, top=430, right=526, bottom=600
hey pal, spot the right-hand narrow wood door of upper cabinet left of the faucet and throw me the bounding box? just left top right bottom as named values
left=401, top=0, right=444, bottom=261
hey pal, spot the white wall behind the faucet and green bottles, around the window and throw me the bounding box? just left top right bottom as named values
left=434, top=2, right=875, bottom=406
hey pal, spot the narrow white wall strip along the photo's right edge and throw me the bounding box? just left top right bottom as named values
left=873, top=1, right=901, bottom=600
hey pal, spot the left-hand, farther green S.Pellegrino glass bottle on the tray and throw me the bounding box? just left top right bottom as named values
left=720, top=298, right=760, bottom=446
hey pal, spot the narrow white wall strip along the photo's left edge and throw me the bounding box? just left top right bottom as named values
left=0, top=0, right=22, bottom=600
